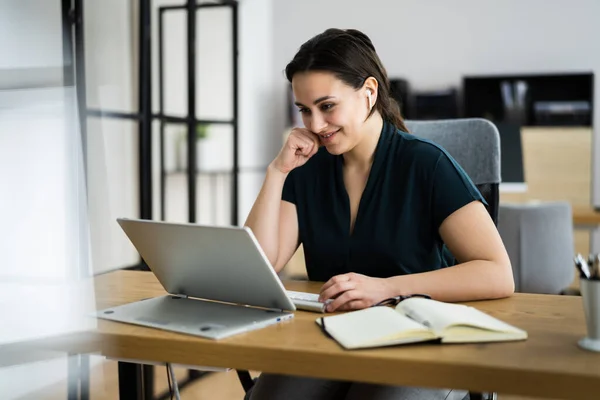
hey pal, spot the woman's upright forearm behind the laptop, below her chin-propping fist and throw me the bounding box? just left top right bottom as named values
left=245, top=165, right=287, bottom=265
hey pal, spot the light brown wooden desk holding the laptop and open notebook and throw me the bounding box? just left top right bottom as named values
left=84, top=271, right=600, bottom=399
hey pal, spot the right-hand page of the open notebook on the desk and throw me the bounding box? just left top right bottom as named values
left=396, top=298, right=520, bottom=333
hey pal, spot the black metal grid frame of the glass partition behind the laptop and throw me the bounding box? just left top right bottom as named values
left=69, top=0, right=239, bottom=238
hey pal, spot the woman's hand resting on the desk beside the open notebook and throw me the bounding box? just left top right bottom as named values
left=319, top=272, right=395, bottom=312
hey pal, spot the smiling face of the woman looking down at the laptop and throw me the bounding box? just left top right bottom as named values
left=292, top=71, right=369, bottom=155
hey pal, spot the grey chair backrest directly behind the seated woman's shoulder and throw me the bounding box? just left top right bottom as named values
left=406, top=118, right=501, bottom=225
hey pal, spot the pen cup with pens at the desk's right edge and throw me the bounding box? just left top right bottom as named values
left=575, top=254, right=600, bottom=352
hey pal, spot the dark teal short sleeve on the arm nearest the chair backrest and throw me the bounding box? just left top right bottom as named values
left=432, top=152, right=487, bottom=228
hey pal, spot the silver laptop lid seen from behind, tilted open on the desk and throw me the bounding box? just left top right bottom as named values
left=117, top=218, right=296, bottom=310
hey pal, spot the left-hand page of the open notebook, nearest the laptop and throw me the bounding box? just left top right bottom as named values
left=317, top=307, right=432, bottom=348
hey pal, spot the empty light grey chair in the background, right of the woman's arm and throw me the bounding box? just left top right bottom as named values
left=498, top=201, right=575, bottom=294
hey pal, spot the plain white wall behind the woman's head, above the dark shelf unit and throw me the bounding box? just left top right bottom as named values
left=273, top=0, right=600, bottom=203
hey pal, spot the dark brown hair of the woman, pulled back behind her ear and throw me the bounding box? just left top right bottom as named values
left=285, top=28, right=408, bottom=132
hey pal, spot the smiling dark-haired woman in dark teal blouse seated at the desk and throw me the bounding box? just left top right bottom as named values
left=246, top=29, right=514, bottom=399
